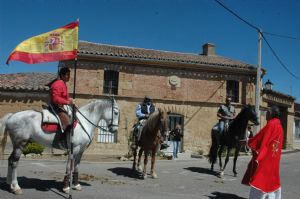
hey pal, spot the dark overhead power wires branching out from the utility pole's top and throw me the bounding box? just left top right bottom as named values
left=215, top=0, right=300, bottom=79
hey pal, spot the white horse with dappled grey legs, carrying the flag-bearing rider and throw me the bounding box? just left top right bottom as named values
left=0, top=99, right=120, bottom=195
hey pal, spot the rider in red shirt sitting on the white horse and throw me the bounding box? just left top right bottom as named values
left=50, top=67, right=74, bottom=133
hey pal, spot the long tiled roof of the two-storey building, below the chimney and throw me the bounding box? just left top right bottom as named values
left=79, top=41, right=256, bottom=70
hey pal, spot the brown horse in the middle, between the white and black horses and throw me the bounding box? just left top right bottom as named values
left=132, top=108, right=168, bottom=179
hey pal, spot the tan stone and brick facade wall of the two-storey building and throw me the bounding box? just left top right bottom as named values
left=60, top=61, right=255, bottom=155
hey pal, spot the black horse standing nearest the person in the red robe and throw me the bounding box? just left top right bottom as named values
left=208, top=105, right=259, bottom=177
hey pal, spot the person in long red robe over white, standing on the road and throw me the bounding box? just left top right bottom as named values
left=242, top=106, right=283, bottom=199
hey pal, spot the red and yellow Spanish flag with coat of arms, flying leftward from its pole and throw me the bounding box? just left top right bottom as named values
left=6, top=21, right=79, bottom=64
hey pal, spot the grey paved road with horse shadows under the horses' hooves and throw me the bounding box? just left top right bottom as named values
left=0, top=152, right=300, bottom=199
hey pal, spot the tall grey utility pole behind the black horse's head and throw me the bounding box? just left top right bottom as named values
left=255, top=29, right=262, bottom=133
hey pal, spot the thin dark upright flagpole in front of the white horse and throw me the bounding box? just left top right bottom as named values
left=68, top=19, right=79, bottom=199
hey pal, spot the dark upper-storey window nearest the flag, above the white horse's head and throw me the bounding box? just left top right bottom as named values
left=103, top=70, right=119, bottom=95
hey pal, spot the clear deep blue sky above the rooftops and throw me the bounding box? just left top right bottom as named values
left=0, top=0, right=300, bottom=102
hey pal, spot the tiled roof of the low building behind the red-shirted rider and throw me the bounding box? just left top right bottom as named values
left=0, top=73, right=57, bottom=91
